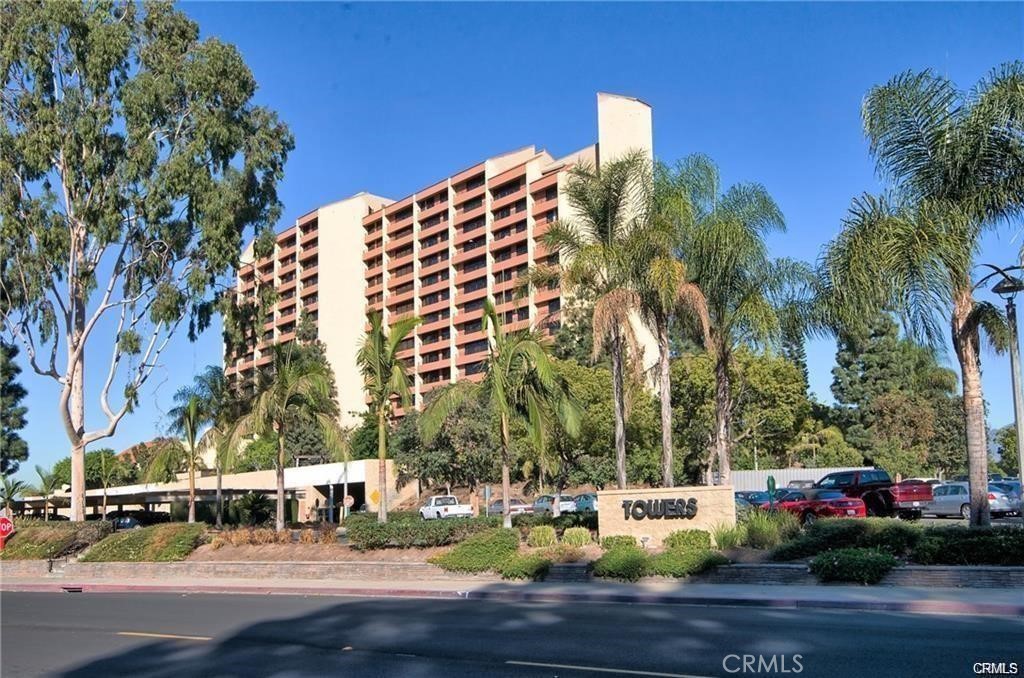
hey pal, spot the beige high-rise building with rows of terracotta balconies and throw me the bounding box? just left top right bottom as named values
left=225, top=93, right=652, bottom=424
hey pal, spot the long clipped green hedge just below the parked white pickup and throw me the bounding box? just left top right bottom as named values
left=346, top=516, right=501, bottom=550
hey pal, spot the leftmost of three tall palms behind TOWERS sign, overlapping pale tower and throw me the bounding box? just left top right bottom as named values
left=531, top=153, right=651, bottom=489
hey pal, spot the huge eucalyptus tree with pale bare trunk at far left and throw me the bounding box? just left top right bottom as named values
left=0, top=2, right=294, bottom=520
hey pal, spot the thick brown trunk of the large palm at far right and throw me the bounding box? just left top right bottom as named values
left=952, top=287, right=992, bottom=526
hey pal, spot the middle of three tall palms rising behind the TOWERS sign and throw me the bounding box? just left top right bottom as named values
left=634, top=166, right=711, bottom=488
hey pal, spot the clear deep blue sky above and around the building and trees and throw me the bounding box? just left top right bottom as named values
left=9, top=3, right=1024, bottom=477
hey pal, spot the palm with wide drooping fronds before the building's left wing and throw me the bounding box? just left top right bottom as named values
left=225, top=346, right=343, bottom=532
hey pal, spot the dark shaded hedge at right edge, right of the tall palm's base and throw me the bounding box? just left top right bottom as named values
left=910, top=526, right=1024, bottom=565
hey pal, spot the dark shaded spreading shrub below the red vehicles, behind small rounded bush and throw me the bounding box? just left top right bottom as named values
left=772, top=518, right=924, bottom=560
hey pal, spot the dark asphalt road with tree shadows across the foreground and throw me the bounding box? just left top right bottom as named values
left=0, top=593, right=1024, bottom=678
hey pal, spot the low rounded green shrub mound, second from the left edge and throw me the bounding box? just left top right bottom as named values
left=82, top=522, right=206, bottom=562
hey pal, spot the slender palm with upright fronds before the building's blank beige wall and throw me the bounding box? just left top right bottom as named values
left=356, top=311, right=421, bottom=522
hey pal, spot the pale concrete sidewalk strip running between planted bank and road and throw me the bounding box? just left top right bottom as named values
left=0, top=578, right=1024, bottom=617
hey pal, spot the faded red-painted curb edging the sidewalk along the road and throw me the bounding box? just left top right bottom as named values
left=0, top=582, right=1024, bottom=618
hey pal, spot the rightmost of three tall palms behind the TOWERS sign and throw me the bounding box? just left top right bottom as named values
left=659, top=155, right=813, bottom=484
